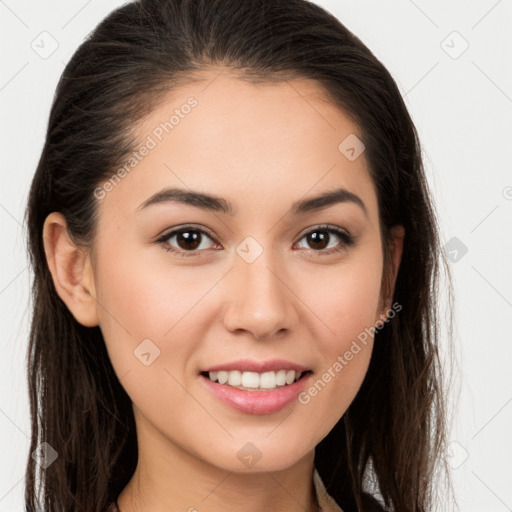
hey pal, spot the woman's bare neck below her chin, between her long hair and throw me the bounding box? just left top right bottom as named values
left=117, top=414, right=319, bottom=512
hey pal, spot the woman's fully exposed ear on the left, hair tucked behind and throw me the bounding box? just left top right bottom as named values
left=43, top=212, right=99, bottom=327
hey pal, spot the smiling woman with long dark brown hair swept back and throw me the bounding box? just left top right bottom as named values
left=26, top=0, right=456, bottom=512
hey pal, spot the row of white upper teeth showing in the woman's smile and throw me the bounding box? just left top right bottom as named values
left=208, top=370, right=302, bottom=390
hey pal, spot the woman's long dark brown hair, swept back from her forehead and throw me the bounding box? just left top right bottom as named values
left=25, top=0, right=451, bottom=512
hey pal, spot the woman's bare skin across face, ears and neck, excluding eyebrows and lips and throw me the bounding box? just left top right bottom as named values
left=44, top=70, right=404, bottom=512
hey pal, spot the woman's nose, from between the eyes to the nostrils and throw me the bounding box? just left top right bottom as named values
left=224, top=249, right=298, bottom=341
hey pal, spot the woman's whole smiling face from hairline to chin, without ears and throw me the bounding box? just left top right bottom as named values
left=83, top=73, right=400, bottom=472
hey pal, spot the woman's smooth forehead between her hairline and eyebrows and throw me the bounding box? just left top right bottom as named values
left=96, top=70, right=375, bottom=223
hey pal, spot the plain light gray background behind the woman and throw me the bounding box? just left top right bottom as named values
left=0, top=0, right=512, bottom=512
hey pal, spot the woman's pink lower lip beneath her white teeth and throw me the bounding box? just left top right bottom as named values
left=200, top=373, right=312, bottom=414
